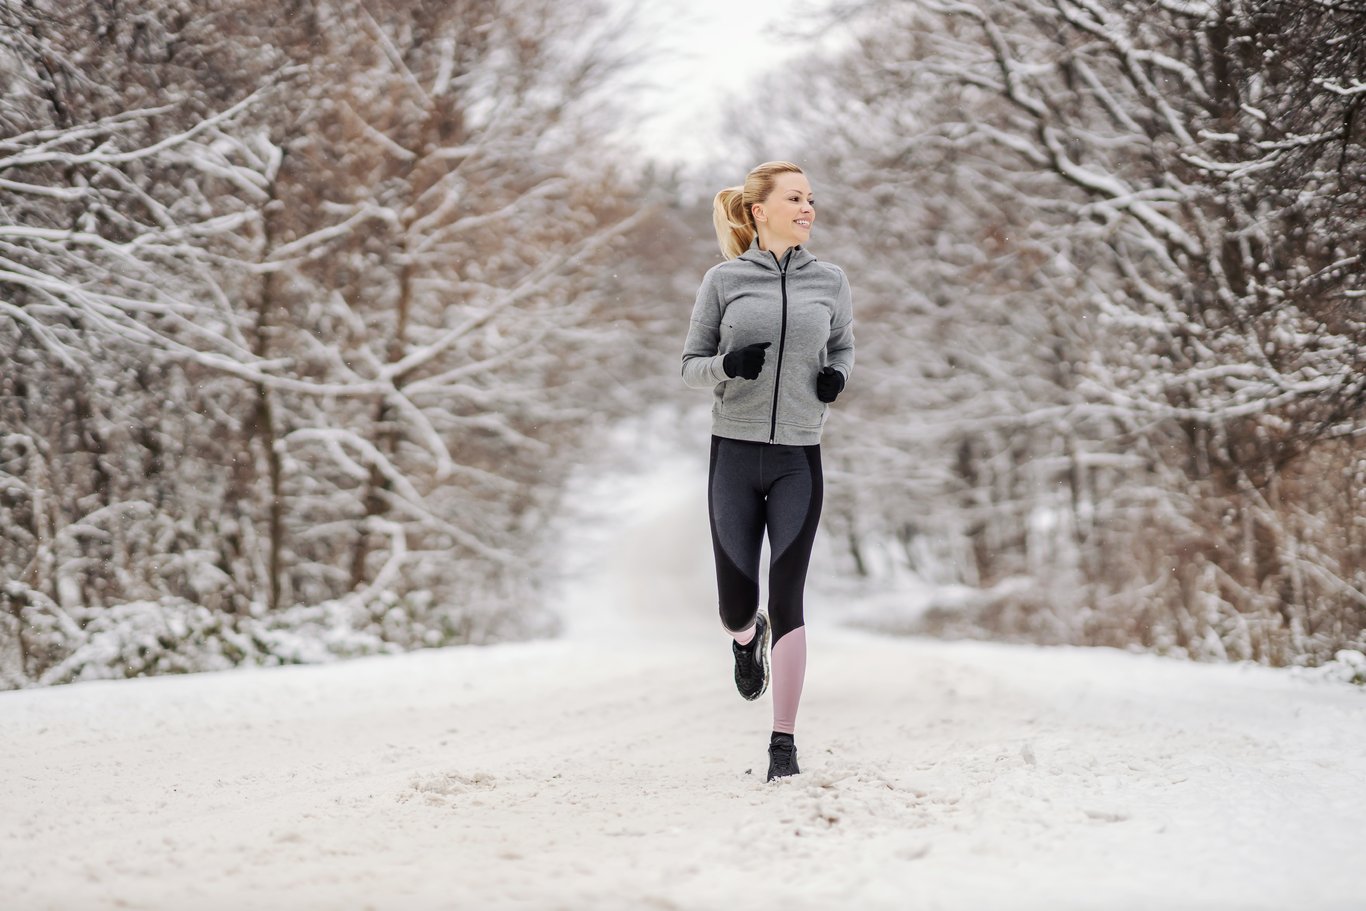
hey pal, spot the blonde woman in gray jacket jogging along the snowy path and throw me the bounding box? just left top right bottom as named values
left=683, top=161, right=854, bottom=781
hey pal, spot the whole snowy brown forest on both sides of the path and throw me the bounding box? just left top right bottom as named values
left=0, top=0, right=1366, bottom=688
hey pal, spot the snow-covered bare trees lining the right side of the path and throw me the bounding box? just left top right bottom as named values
left=746, top=0, right=1366, bottom=661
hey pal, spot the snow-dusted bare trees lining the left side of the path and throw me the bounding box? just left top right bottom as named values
left=0, top=0, right=661, bottom=679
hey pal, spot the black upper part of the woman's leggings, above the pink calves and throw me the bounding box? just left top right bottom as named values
left=708, top=437, right=824, bottom=645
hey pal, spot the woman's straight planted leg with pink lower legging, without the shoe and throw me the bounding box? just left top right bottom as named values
left=762, top=445, right=825, bottom=733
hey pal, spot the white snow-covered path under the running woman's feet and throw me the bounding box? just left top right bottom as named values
left=0, top=458, right=1366, bottom=911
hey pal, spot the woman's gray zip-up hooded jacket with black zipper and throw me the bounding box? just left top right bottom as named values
left=683, top=240, right=854, bottom=445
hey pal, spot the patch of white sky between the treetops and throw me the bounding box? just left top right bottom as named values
left=620, top=0, right=820, bottom=163
